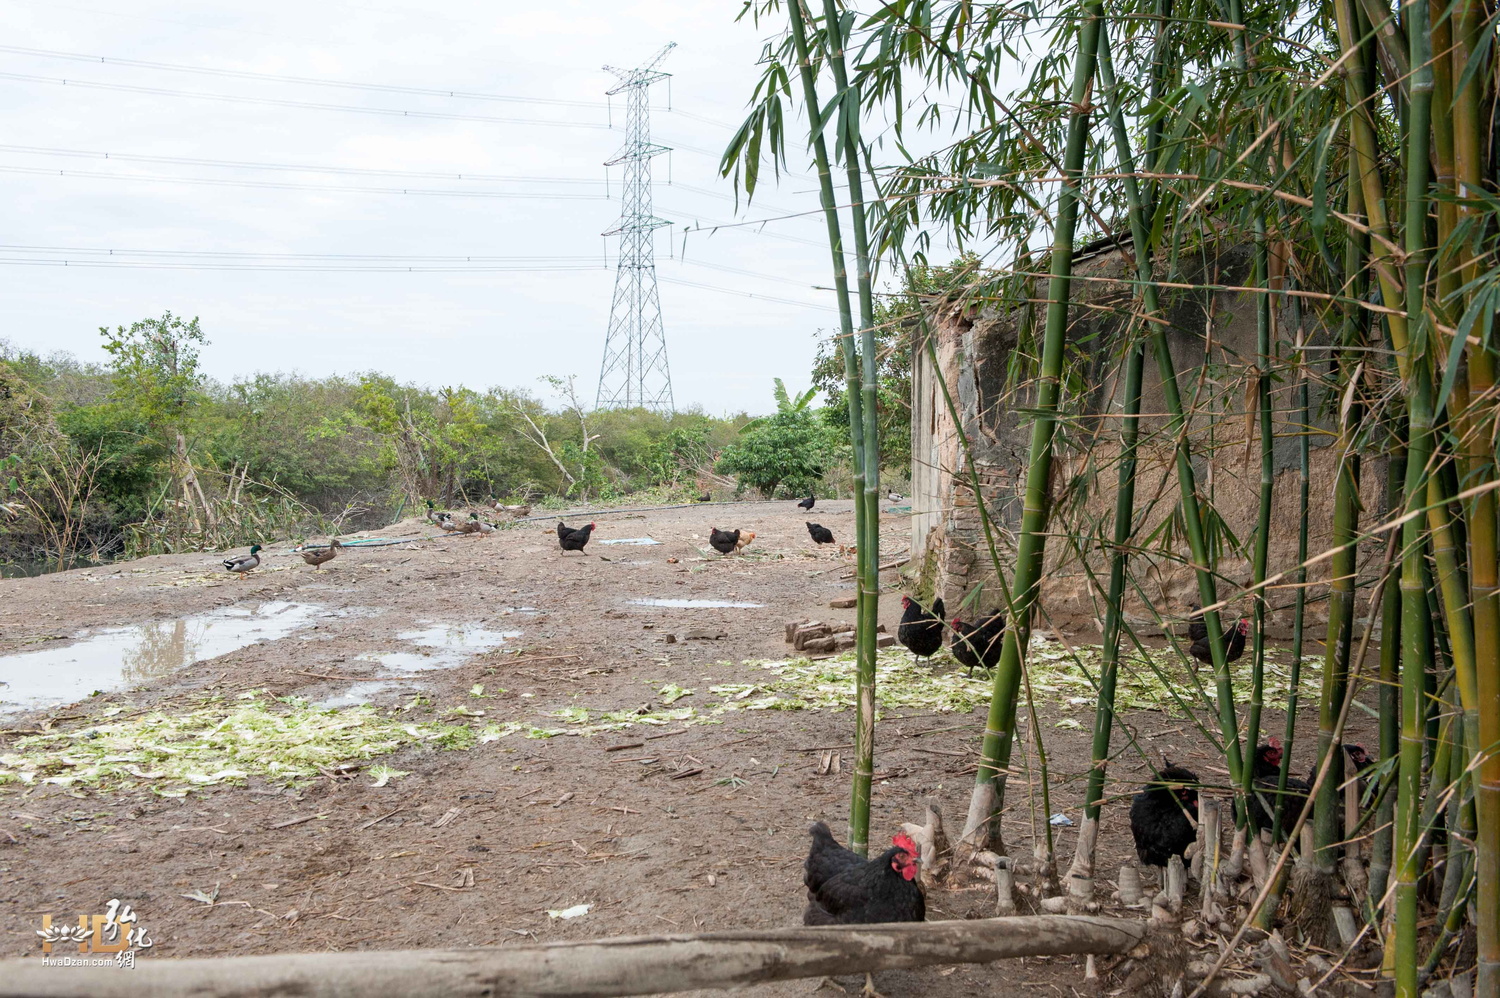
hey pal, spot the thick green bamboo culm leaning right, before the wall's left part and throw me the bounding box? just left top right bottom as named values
left=963, top=3, right=1104, bottom=851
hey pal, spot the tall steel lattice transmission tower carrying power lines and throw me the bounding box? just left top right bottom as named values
left=594, top=42, right=677, bottom=413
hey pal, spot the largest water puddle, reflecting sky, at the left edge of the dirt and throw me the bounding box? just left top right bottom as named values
left=0, top=602, right=324, bottom=714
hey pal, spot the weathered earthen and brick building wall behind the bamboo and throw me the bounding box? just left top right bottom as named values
left=911, top=244, right=1385, bottom=636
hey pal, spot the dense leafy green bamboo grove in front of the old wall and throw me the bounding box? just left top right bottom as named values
left=723, top=0, right=1500, bottom=998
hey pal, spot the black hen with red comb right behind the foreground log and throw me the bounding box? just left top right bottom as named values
left=803, top=821, right=927, bottom=926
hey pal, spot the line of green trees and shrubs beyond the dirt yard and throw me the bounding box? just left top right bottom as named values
left=0, top=312, right=905, bottom=573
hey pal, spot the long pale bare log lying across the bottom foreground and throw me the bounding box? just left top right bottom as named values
left=0, top=915, right=1146, bottom=998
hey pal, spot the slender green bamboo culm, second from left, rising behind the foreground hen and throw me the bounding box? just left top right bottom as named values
left=809, top=0, right=881, bottom=855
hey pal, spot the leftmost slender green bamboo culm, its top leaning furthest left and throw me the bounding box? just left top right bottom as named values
left=788, top=0, right=879, bottom=855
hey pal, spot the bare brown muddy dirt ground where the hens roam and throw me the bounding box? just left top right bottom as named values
left=0, top=501, right=1362, bottom=998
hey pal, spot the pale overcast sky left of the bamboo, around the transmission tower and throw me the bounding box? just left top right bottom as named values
left=0, top=0, right=858, bottom=414
